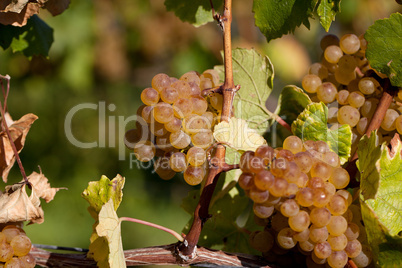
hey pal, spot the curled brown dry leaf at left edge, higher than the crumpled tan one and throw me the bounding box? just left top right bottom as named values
left=0, top=114, right=38, bottom=182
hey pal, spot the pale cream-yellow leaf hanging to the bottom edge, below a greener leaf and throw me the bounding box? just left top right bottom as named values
left=90, top=199, right=126, bottom=268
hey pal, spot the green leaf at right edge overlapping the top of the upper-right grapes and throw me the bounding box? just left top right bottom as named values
left=364, top=13, right=402, bottom=87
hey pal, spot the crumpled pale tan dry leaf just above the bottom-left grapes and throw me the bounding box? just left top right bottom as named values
left=0, top=172, right=62, bottom=223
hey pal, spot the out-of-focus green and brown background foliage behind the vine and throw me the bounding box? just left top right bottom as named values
left=0, top=0, right=400, bottom=264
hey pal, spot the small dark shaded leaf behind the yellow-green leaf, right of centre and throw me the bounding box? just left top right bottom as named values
left=275, top=86, right=311, bottom=125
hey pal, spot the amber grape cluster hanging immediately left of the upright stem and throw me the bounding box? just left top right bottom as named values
left=134, top=70, right=223, bottom=185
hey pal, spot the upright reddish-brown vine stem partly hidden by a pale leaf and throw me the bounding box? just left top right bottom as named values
left=179, top=0, right=239, bottom=259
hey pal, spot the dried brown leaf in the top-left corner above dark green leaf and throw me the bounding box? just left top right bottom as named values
left=0, top=2, right=41, bottom=27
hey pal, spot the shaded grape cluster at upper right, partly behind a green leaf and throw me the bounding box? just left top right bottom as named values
left=302, top=34, right=402, bottom=151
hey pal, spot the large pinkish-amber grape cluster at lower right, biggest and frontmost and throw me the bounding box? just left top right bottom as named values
left=238, top=136, right=371, bottom=268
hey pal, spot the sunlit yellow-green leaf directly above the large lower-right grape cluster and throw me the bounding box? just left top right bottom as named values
left=292, top=102, right=352, bottom=164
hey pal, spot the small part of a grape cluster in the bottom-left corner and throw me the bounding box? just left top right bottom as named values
left=0, top=225, right=36, bottom=268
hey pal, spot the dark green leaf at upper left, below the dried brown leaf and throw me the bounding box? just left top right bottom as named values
left=0, top=15, right=53, bottom=58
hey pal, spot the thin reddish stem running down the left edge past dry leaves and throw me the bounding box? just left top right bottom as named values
left=0, top=75, right=29, bottom=185
